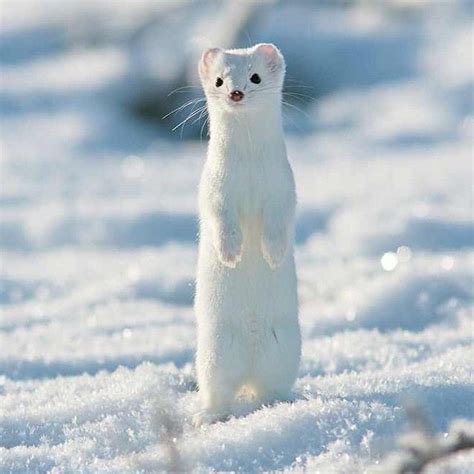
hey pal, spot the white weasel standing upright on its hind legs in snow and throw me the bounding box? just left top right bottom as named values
left=195, top=44, right=301, bottom=425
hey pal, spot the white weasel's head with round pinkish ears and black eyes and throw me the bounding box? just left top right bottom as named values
left=199, top=43, right=285, bottom=113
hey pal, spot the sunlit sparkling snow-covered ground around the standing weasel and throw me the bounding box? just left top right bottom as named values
left=0, top=1, right=474, bottom=473
